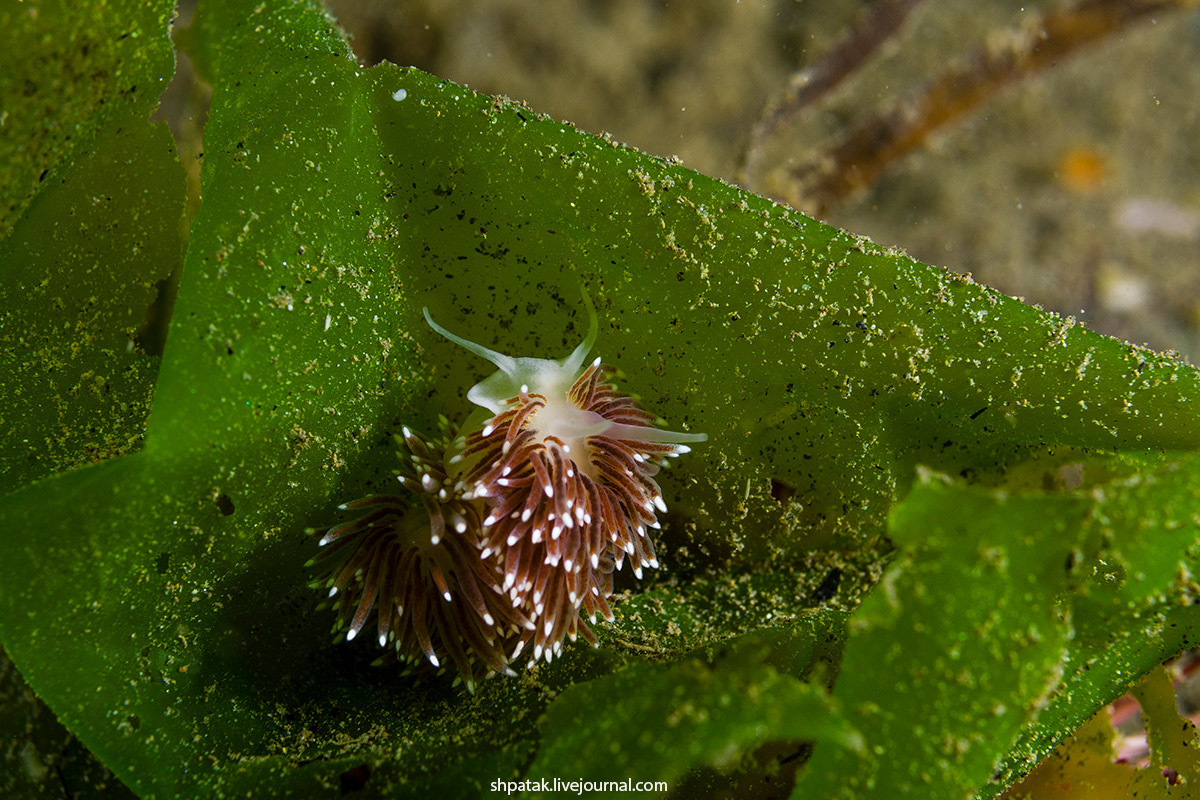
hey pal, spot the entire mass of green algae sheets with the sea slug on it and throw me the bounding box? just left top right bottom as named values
left=0, top=0, right=1200, bottom=798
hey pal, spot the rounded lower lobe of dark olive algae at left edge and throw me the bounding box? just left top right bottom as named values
left=0, top=120, right=184, bottom=493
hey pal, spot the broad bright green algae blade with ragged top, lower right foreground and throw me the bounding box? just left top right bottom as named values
left=793, top=475, right=1085, bottom=798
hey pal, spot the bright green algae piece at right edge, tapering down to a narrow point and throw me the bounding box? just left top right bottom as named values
left=984, top=456, right=1200, bottom=796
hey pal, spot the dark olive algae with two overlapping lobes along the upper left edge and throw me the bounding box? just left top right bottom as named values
left=0, top=1, right=184, bottom=494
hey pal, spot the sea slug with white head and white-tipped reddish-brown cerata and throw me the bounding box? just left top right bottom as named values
left=317, top=294, right=707, bottom=688
